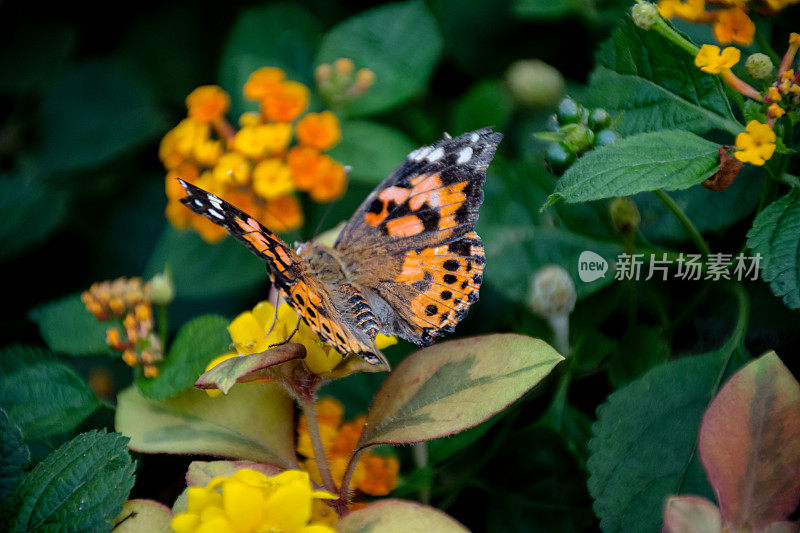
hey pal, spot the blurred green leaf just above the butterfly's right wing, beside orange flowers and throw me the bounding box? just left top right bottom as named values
left=330, top=120, right=417, bottom=186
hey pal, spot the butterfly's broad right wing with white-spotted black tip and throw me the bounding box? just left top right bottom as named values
left=334, top=128, right=502, bottom=345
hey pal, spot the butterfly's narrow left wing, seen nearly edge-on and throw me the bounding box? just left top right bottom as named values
left=180, top=180, right=382, bottom=363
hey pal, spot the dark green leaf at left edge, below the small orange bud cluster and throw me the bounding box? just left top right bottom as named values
left=0, top=345, right=100, bottom=440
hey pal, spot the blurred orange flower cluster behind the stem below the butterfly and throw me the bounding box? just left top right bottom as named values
left=297, top=398, right=400, bottom=496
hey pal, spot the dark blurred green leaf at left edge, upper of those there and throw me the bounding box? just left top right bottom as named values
left=0, top=176, right=67, bottom=260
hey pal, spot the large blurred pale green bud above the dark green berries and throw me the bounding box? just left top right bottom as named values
left=506, top=59, right=565, bottom=107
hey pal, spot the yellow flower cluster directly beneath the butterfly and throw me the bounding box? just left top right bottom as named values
left=206, top=301, right=397, bottom=386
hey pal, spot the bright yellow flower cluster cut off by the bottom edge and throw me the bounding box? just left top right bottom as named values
left=170, top=468, right=336, bottom=533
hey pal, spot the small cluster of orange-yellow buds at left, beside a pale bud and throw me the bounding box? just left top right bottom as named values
left=81, top=278, right=164, bottom=378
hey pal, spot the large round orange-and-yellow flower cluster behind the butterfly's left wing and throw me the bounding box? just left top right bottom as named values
left=159, top=67, right=347, bottom=242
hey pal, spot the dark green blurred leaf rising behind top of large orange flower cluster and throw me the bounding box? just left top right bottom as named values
left=219, top=2, right=322, bottom=117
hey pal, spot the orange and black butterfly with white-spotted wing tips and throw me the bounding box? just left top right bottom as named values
left=180, top=128, right=503, bottom=364
